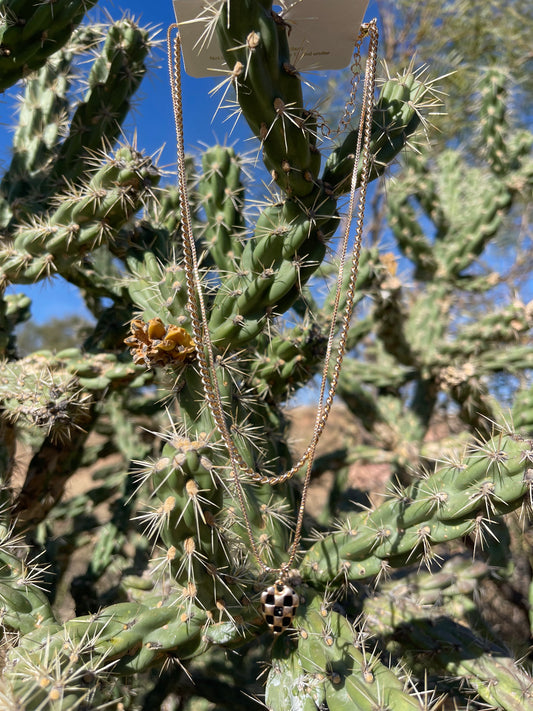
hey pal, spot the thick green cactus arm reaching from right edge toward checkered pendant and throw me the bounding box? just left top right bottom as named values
left=301, top=434, right=532, bottom=584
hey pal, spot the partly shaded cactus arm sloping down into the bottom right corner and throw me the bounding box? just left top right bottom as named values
left=364, top=557, right=533, bottom=711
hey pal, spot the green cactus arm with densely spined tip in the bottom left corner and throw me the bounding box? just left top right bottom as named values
left=3, top=596, right=211, bottom=711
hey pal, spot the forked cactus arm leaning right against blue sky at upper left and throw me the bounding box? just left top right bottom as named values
left=1, top=18, right=150, bottom=231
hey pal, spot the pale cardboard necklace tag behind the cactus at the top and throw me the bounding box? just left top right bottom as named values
left=174, top=0, right=368, bottom=77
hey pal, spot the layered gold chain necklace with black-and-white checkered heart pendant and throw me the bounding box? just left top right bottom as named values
left=167, top=20, right=378, bottom=634
